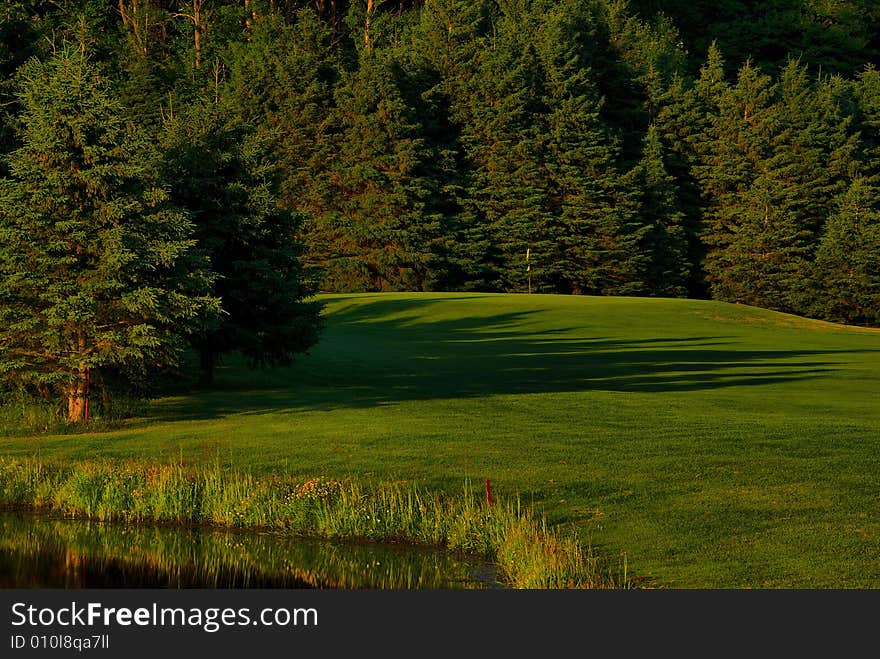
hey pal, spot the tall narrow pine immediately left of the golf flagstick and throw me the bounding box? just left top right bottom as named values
left=456, top=0, right=549, bottom=292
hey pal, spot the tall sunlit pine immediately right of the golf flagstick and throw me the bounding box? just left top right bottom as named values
left=535, top=0, right=647, bottom=294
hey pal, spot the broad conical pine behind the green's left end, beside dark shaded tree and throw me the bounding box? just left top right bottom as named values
left=304, top=48, right=440, bottom=291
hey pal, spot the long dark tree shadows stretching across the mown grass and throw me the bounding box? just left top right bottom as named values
left=154, top=296, right=864, bottom=420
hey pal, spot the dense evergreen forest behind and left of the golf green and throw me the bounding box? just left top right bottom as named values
left=0, top=0, right=880, bottom=421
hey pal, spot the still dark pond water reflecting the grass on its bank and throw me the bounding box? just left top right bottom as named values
left=0, top=512, right=498, bottom=589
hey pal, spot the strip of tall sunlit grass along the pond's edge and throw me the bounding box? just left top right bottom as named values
left=0, top=460, right=626, bottom=588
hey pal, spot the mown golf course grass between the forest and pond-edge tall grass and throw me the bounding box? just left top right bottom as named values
left=0, top=294, right=880, bottom=588
